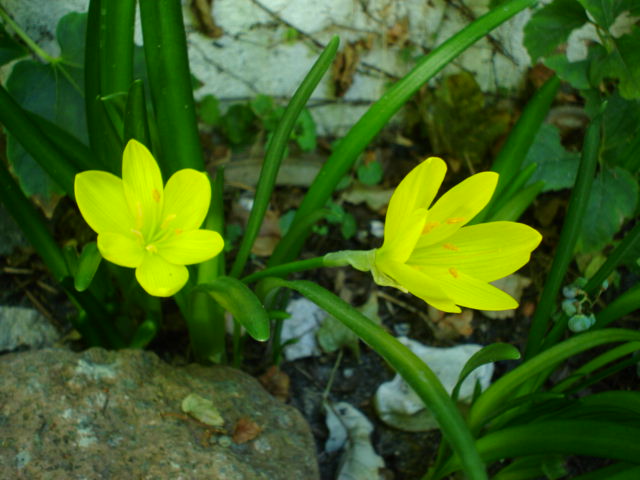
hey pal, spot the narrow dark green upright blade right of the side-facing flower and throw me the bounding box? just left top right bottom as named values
left=525, top=115, right=602, bottom=358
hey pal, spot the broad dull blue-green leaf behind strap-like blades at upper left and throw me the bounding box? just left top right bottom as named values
left=7, top=13, right=87, bottom=211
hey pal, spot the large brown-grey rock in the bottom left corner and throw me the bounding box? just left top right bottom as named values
left=0, top=348, right=319, bottom=480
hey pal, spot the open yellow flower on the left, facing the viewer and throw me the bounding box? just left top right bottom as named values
left=74, top=140, right=224, bottom=297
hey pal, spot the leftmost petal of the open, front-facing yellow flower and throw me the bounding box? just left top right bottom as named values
left=74, top=170, right=133, bottom=234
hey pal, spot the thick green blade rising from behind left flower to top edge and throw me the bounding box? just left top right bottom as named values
left=140, top=0, right=204, bottom=174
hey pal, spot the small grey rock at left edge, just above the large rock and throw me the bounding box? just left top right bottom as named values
left=0, top=306, right=60, bottom=352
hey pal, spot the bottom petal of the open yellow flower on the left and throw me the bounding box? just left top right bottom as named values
left=136, top=253, right=189, bottom=297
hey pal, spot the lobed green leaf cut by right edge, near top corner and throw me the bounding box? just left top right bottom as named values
left=589, top=27, right=640, bottom=99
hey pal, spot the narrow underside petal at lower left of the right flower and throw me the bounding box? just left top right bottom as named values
left=374, top=262, right=460, bottom=313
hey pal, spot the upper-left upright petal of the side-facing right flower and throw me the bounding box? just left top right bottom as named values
left=384, top=157, right=447, bottom=248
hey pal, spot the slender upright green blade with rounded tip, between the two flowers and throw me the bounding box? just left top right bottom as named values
left=230, top=37, right=340, bottom=277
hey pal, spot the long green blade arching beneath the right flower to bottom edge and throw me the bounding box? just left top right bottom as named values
left=262, top=277, right=487, bottom=480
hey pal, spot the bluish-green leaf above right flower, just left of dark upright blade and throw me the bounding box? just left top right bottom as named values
left=522, top=123, right=580, bottom=192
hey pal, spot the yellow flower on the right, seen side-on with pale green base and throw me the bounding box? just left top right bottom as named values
left=325, top=157, right=542, bottom=312
